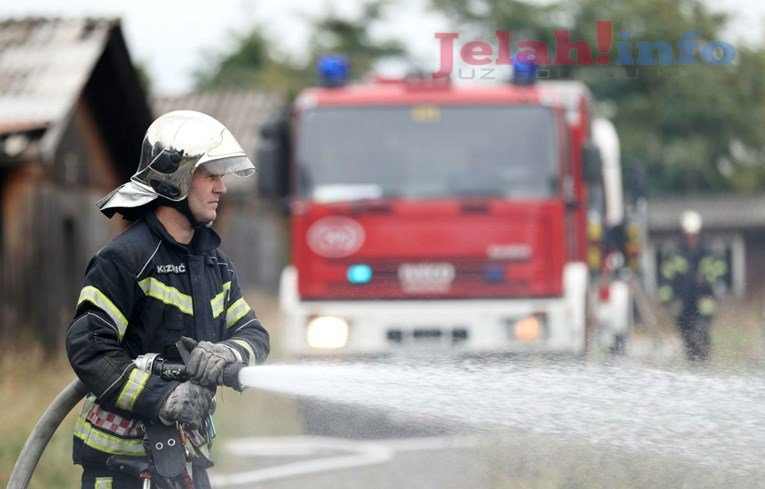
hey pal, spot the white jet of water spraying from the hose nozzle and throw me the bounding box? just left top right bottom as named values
left=240, top=359, right=765, bottom=473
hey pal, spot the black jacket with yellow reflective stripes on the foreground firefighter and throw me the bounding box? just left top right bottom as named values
left=66, top=212, right=269, bottom=465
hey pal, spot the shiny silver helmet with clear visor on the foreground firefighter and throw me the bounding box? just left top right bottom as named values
left=97, top=110, right=255, bottom=217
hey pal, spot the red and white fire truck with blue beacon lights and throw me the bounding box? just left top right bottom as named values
left=258, top=56, right=631, bottom=355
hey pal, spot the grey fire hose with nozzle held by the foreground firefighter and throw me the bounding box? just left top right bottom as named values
left=6, top=342, right=244, bottom=489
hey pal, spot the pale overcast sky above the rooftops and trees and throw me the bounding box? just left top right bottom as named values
left=0, top=0, right=765, bottom=94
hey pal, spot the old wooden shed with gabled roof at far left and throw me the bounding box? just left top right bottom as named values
left=0, top=18, right=152, bottom=349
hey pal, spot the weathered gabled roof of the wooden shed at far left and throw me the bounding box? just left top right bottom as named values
left=0, top=17, right=151, bottom=175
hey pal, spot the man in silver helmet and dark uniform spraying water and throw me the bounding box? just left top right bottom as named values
left=66, top=111, right=269, bottom=489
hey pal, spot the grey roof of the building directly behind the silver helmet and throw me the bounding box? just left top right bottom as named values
left=153, top=90, right=283, bottom=158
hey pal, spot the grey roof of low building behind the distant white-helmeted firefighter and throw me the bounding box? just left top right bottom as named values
left=648, top=195, right=765, bottom=231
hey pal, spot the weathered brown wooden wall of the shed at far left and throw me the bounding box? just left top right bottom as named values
left=0, top=102, right=123, bottom=350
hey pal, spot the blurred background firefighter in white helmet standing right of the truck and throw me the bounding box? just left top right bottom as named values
left=659, top=210, right=727, bottom=362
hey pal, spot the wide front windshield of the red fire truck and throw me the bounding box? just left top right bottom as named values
left=296, top=105, right=559, bottom=201
